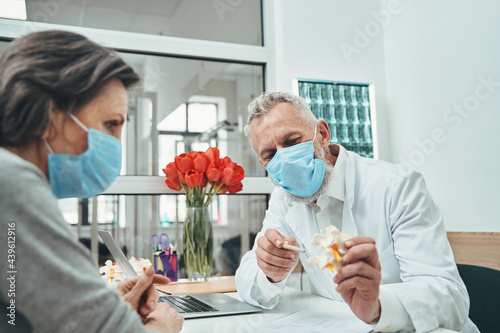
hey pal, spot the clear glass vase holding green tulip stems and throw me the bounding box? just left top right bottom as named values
left=182, top=207, right=214, bottom=281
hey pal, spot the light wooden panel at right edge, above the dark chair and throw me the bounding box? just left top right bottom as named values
left=448, top=232, right=500, bottom=270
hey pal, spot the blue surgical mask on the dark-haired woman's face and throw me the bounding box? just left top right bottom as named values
left=45, top=115, right=122, bottom=199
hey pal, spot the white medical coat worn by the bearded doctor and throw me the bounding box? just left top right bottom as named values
left=236, top=152, right=478, bottom=332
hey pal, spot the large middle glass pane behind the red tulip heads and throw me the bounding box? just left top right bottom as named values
left=122, top=53, right=265, bottom=177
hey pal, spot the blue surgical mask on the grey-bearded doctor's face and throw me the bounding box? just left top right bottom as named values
left=266, top=127, right=325, bottom=198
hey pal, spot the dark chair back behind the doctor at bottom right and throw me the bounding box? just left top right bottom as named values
left=457, top=264, right=500, bottom=333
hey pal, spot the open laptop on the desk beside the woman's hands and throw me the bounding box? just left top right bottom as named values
left=98, top=230, right=262, bottom=319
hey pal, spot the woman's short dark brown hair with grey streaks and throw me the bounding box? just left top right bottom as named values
left=0, top=30, right=139, bottom=147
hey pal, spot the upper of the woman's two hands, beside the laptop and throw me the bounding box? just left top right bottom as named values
left=116, top=267, right=170, bottom=319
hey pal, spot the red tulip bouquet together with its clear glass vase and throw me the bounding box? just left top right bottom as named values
left=163, top=147, right=245, bottom=280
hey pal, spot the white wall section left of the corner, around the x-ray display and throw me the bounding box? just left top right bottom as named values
left=274, top=0, right=390, bottom=160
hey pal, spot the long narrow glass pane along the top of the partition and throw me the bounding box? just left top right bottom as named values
left=23, top=0, right=262, bottom=46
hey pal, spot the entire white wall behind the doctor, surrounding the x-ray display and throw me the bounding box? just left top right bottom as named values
left=276, top=0, right=500, bottom=231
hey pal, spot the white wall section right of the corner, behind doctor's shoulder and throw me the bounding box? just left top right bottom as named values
left=384, top=0, right=500, bottom=231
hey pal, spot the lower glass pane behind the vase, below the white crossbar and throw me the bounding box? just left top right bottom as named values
left=74, top=194, right=269, bottom=277
